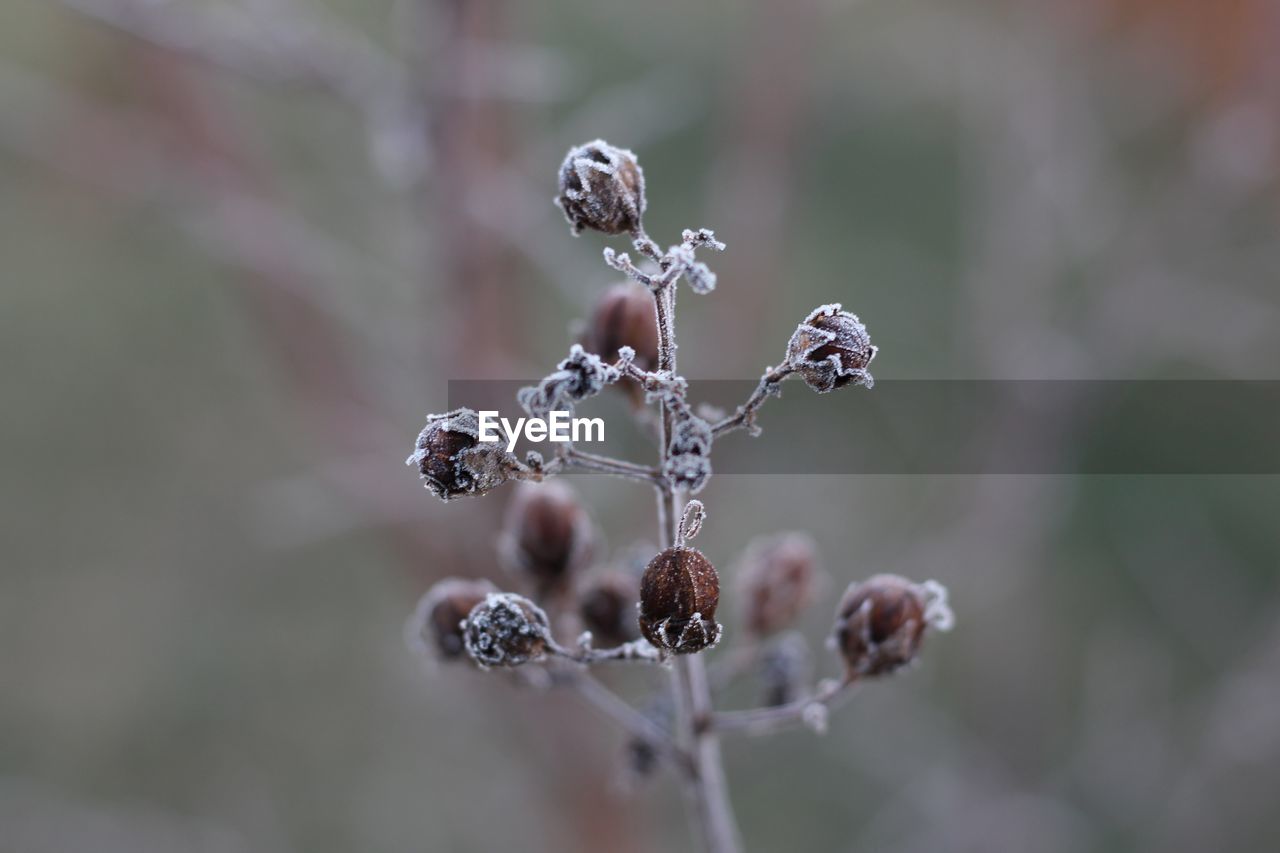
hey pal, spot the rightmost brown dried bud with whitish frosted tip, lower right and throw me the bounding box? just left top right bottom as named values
left=832, top=575, right=952, bottom=678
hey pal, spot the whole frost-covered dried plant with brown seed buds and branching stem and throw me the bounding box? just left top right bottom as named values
left=407, top=140, right=951, bottom=853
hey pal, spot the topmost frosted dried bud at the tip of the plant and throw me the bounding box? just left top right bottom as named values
left=557, top=140, right=645, bottom=234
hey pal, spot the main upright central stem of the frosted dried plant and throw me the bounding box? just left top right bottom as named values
left=653, top=270, right=742, bottom=853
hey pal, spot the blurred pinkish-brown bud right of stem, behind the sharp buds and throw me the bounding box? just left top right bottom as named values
left=736, top=533, right=818, bottom=637
